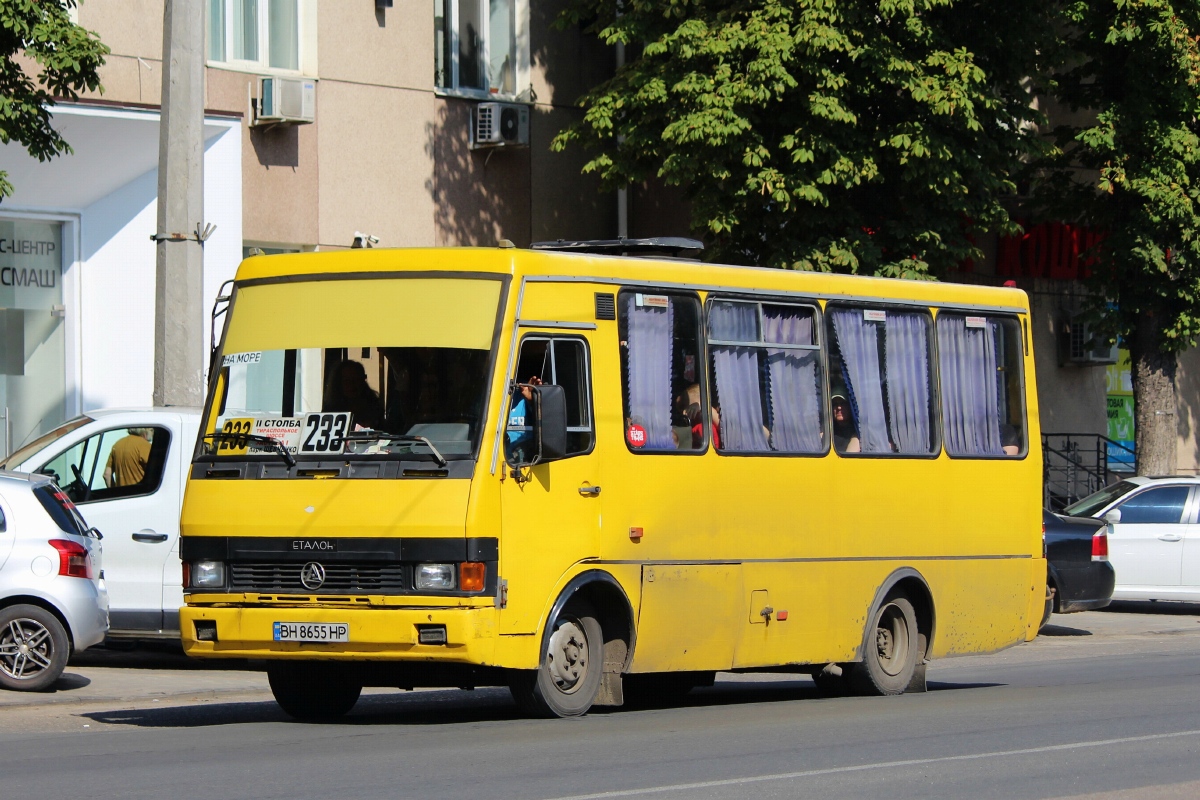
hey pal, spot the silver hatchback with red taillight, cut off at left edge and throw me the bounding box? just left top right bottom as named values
left=0, top=471, right=108, bottom=692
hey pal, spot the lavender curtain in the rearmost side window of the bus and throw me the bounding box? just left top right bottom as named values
left=937, top=317, right=1004, bottom=456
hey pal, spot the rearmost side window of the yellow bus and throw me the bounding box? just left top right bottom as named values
left=937, top=312, right=1026, bottom=457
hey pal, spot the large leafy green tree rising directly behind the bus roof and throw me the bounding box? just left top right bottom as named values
left=553, top=0, right=1052, bottom=277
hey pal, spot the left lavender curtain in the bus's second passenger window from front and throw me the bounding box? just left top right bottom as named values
left=708, top=302, right=770, bottom=452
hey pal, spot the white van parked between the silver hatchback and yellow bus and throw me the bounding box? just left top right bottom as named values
left=0, top=408, right=200, bottom=638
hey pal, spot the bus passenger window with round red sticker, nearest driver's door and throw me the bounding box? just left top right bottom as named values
left=617, top=291, right=709, bottom=453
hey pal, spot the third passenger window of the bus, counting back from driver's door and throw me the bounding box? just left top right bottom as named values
left=828, top=306, right=937, bottom=456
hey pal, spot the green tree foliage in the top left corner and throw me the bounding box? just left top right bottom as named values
left=0, top=0, right=108, bottom=199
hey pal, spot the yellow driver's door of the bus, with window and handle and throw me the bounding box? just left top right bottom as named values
left=500, top=332, right=601, bottom=633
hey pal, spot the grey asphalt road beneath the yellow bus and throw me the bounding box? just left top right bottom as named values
left=0, top=603, right=1200, bottom=800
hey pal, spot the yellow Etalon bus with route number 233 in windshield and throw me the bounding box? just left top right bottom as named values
left=180, top=240, right=1046, bottom=718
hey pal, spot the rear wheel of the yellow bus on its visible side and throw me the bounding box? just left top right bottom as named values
left=851, top=594, right=920, bottom=696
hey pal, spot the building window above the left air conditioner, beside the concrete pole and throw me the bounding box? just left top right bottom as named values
left=208, top=0, right=301, bottom=71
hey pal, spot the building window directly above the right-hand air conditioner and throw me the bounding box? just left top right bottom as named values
left=433, top=0, right=529, bottom=97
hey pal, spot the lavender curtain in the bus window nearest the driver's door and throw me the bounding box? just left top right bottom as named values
left=628, top=293, right=674, bottom=450
